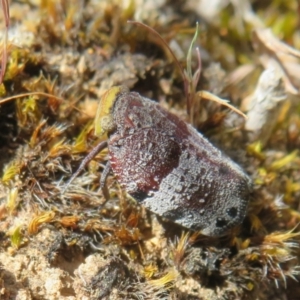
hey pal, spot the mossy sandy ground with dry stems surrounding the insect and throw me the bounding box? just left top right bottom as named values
left=0, top=0, right=300, bottom=300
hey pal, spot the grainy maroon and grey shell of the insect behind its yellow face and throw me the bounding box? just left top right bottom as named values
left=103, top=88, right=251, bottom=236
